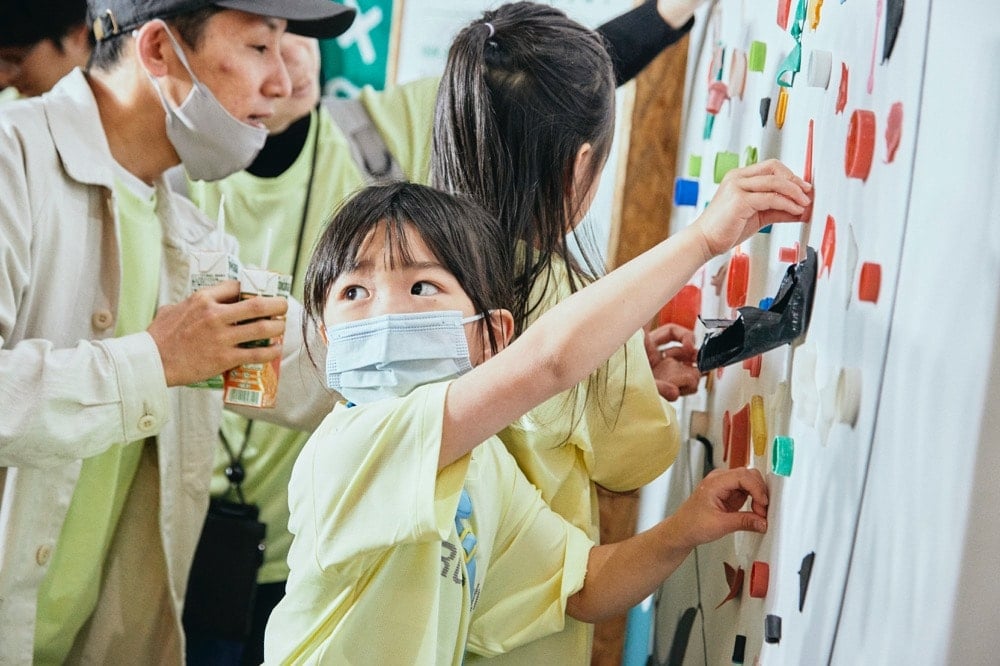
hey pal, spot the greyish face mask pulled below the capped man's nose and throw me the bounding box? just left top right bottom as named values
left=146, top=23, right=267, bottom=180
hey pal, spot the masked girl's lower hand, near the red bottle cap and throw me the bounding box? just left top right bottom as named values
left=667, top=467, right=768, bottom=548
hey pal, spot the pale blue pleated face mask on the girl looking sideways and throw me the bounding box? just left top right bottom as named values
left=326, top=310, right=483, bottom=405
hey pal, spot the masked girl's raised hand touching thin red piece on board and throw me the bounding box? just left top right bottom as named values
left=694, top=159, right=812, bottom=257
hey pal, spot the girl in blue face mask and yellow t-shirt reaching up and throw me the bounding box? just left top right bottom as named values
left=265, top=165, right=810, bottom=665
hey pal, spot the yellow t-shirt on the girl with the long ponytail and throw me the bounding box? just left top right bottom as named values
left=466, top=250, right=680, bottom=666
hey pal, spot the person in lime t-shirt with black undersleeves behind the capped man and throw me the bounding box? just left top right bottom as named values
left=179, top=0, right=699, bottom=664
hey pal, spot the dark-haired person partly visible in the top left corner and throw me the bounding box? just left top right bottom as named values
left=0, top=0, right=90, bottom=99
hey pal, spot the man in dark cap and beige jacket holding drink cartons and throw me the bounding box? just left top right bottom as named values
left=0, top=0, right=354, bottom=664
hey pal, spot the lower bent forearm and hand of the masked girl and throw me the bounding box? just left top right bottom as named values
left=566, top=467, right=767, bottom=622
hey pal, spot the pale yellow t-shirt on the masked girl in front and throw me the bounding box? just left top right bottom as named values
left=265, top=383, right=593, bottom=666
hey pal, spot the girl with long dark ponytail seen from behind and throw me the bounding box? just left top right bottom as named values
left=431, top=1, right=699, bottom=664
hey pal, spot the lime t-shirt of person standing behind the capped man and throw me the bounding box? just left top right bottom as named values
left=189, top=79, right=437, bottom=583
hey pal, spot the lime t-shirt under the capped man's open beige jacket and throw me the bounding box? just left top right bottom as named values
left=34, top=171, right=162, bottom=664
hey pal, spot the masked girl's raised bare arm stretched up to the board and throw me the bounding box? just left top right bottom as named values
left=438, top=160, right=811, bottom=467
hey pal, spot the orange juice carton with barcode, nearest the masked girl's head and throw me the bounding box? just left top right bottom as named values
left=222, top=268, right=292, bottom=407
